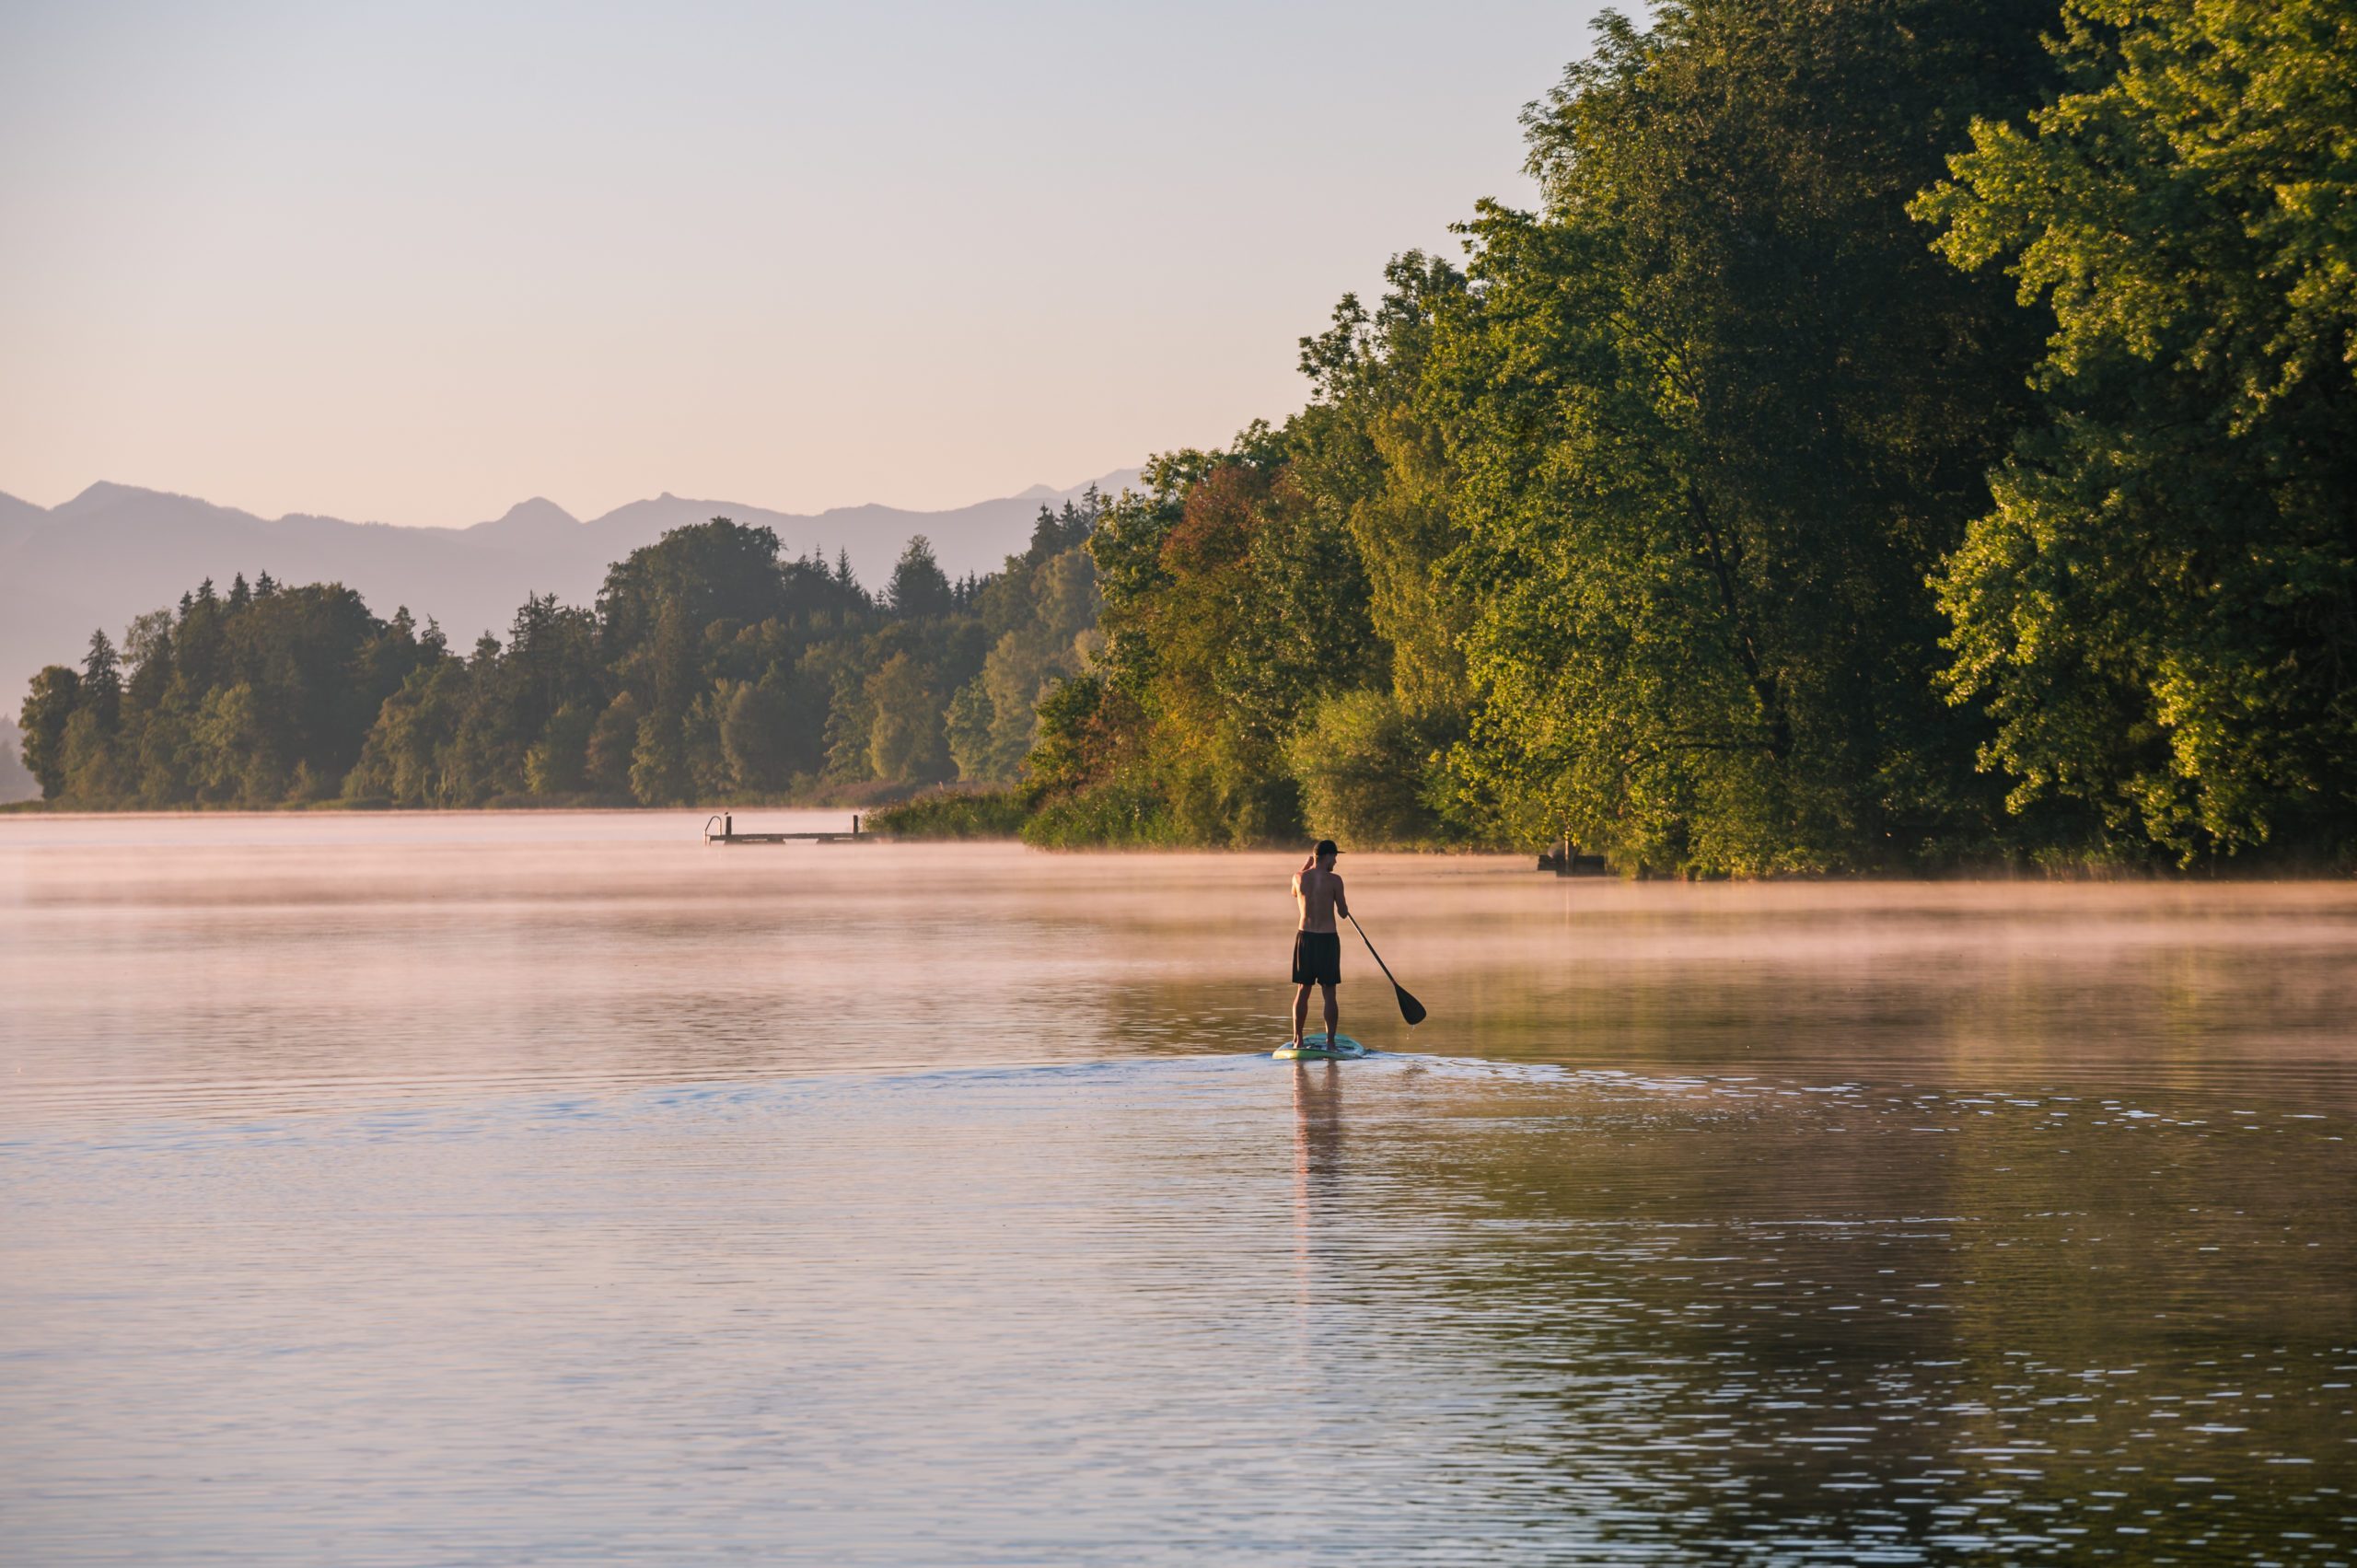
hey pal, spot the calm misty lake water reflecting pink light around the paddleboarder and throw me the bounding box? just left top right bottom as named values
left=0, top=814, right=2357, bottom=1565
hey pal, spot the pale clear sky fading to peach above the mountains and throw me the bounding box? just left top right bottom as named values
left=0, top=0, right=1636, bottom=524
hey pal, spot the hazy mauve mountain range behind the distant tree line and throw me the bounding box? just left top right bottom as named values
left=0, top=470, right=1138, bottom=698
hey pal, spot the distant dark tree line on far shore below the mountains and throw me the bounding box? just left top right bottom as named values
left=21, top=502, right=1101, bottom=808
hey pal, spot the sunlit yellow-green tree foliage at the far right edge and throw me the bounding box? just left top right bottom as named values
left=1916, top=0, right=2357, bottom=861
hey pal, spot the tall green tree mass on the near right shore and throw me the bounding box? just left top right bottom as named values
left=990, top=0, right=2357, bottom=875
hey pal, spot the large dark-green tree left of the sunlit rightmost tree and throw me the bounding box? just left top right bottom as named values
left=1426, top=0, right=2046, bottom=873
